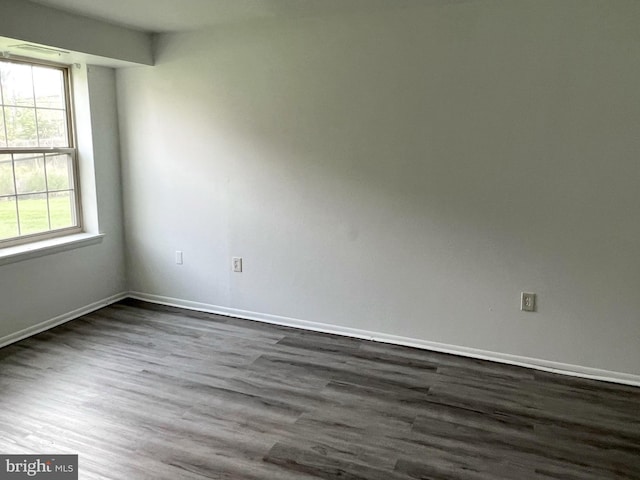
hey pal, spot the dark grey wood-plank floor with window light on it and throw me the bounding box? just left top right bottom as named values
left=0, top=300, right=640, bottom=480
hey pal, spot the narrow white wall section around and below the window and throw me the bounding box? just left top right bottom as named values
left=0, top=67, right=127, bottom=339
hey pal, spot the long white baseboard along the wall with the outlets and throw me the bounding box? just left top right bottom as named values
left=129, top=292, right=640, bottom=386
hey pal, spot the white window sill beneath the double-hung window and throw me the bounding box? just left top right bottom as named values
left=0, top=233, right=104, bottom=266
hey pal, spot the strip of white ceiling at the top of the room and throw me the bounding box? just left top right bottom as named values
left=32, top=0, right=440, bottom=32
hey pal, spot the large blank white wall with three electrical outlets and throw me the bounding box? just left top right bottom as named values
left=117, top=0, right=640, bottom=375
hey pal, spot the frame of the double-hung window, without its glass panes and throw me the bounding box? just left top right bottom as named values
left=0, top=55, right=83, bottom=250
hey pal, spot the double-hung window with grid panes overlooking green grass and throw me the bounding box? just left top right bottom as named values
left=0, top=59, right=81, bottom=248
